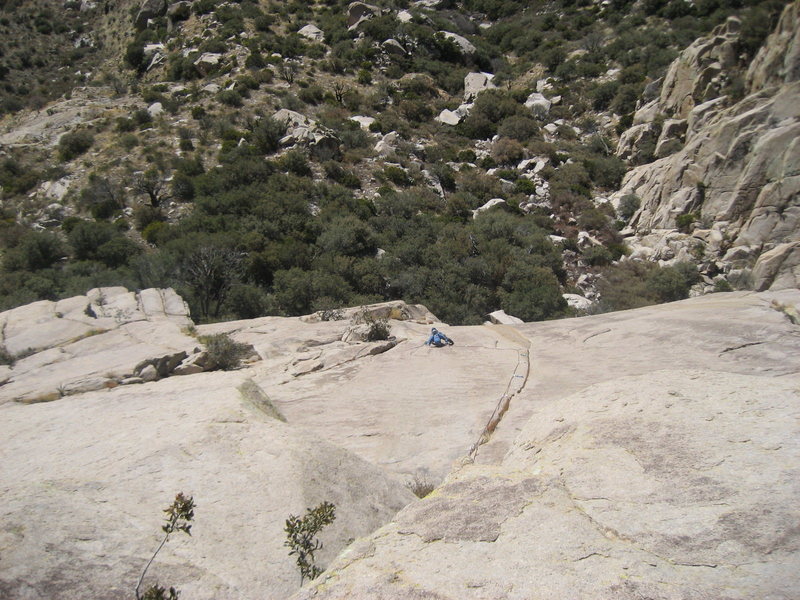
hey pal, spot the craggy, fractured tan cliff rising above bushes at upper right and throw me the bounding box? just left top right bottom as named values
left=615, top=2, right=800, bottom=289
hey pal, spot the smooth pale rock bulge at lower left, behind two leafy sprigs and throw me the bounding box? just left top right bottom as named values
left=0, top=373, right=414, bottom=600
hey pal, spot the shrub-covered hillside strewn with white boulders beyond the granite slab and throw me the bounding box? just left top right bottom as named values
left=0, top=0, right=798, bottom=324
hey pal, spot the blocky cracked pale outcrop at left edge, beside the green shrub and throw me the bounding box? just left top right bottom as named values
left=0, top=287, right=198, bottom=404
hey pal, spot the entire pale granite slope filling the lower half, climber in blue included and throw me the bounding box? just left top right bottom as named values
left=0, top=289, right=800, bottom=599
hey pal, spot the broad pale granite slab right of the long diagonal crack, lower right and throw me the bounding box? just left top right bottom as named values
left=295, top=291, right=800, bottom=600
